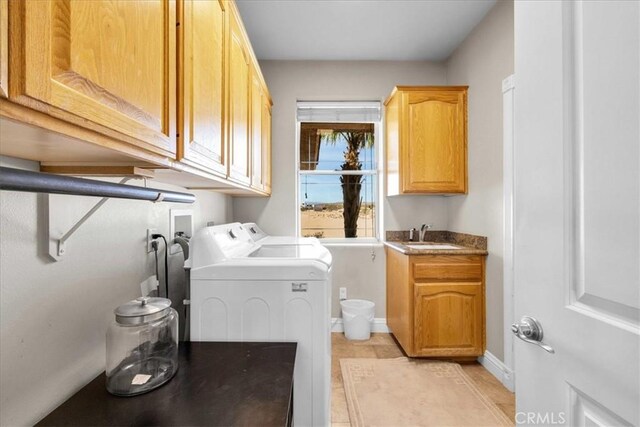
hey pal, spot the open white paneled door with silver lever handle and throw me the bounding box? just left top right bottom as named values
left=514, top=0, right=640, bottom=426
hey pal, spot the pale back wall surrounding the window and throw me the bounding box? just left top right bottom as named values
left=233, top=61, right=448, bottom=317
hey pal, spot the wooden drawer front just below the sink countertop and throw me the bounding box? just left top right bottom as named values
left=411, top=255, right=482, bottom=280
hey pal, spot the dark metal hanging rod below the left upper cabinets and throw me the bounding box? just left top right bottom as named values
left=0, top=167, right=196, bottom=203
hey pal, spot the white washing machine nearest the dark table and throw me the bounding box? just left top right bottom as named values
left=190, top=223, right=331, bottom=426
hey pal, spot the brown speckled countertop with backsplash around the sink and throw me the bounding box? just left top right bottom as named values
left=384, top=230, right=489, bottom=255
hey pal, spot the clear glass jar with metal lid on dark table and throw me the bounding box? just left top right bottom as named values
left=106, top=297, right=178, bottom=396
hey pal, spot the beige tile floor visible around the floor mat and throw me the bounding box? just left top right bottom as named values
left=331, top=333, right=515, bottom=427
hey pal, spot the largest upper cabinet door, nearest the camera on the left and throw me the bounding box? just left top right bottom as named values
left=10, top=0, right=176, bottom=157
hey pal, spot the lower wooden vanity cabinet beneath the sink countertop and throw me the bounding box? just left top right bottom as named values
left=386, top=247, right=485, bottom=358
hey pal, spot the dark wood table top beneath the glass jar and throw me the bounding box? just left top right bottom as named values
left=38, top=342, right=296, bottom=426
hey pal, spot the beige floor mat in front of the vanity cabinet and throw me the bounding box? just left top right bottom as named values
left=340, top=357, right=513, bottom=427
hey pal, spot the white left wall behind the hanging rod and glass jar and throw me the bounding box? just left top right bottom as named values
left=0, top=155, right=232, bottom=426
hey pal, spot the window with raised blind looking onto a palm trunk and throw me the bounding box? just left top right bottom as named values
left=298, top=102, right=380, bottom=239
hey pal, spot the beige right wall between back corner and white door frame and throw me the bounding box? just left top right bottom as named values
left=447, top=1, right=514, bottom=360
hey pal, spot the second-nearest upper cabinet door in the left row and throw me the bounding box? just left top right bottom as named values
left=178, top=0, right=228, bottom=176
